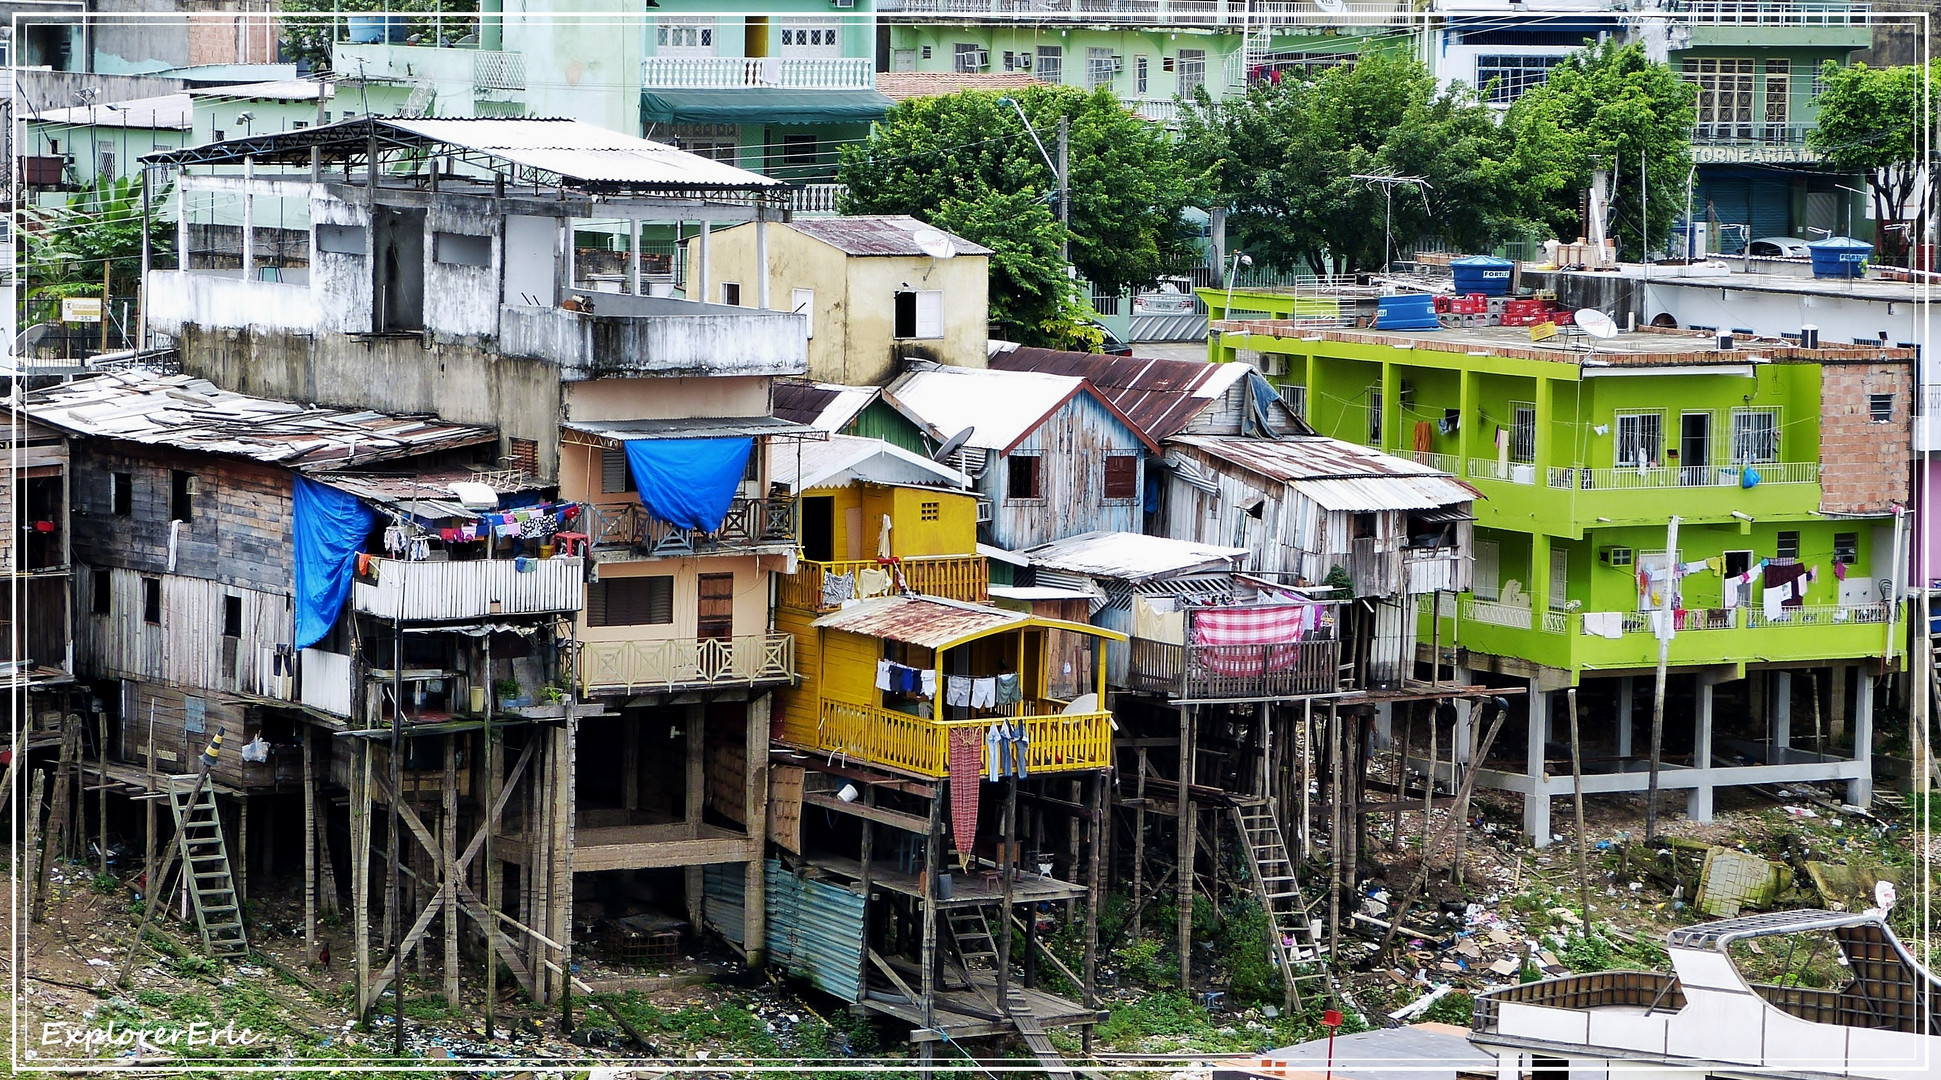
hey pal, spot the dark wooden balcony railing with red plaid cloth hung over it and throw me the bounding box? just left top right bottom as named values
left=1128, top=637, right=1341, bottom=701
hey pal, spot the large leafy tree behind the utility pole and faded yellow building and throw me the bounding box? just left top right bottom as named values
left=837, top=85, right=1196, bottom=342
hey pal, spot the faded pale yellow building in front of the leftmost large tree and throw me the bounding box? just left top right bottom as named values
left=687, top=216, right=990, bottom=385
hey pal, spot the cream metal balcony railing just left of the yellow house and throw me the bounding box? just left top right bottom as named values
left=580, top=633, right=796, bottom=693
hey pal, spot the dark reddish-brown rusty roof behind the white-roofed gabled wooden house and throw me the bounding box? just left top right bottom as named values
left=990, top=346, right=1252, bottom=443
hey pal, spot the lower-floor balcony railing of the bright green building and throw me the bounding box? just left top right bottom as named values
left=1419, top=594, right=1906, bottom=674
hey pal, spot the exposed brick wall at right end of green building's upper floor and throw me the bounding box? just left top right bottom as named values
left=1821, top=363, right=1914, bottom=513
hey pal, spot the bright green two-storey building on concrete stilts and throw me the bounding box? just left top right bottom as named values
left=1200, top=289, right=1914, bottom=843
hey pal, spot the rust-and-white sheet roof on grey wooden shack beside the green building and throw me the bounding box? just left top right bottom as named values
left=1174, top=435, right=1479, bottom=511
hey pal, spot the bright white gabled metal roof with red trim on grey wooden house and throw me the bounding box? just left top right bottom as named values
left=883, top=365, right=1159, bottom=453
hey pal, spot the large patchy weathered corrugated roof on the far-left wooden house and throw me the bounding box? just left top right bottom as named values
left=25, top=369, right=497, bottom=470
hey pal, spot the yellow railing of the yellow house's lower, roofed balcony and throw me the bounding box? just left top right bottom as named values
left=815, top=701, right=1112, bottom=777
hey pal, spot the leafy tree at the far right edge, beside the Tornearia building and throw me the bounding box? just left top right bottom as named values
left=1807, top=60, right=1941, bottom=247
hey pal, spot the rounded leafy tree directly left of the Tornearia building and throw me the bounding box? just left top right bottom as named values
left=1504, top=41, right=1698, bottom=256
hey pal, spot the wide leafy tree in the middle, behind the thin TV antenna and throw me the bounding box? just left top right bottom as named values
left=1180, top=52, right=1535, bottom=274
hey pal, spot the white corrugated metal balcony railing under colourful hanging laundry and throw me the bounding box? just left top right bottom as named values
left=351, top=557, right=586, bottom=622
